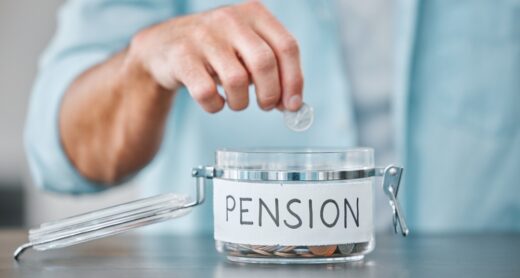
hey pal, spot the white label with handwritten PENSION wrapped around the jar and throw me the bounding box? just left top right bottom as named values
left=213, top=178, right=373, bottom=245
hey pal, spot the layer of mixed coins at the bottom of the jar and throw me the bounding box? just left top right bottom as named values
left=224, top=242, right=369, bottom=258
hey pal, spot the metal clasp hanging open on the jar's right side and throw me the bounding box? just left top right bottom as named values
left=376, top=165, right=410, bottom=236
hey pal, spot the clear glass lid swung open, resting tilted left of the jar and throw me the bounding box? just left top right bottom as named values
left=14, top=193, right=196, bottom=258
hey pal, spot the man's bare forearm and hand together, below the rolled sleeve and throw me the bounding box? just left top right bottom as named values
left=59, top=2, right=303, bottom=184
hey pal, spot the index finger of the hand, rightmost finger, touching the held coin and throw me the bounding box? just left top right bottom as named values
left=244, top=2, right=303, bottom=111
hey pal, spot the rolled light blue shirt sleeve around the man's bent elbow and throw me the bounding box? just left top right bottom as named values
left=24, top=0, right=182, bottom=194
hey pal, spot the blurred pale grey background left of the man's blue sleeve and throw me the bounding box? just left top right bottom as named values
left=0, top=0, right=136, bottom=228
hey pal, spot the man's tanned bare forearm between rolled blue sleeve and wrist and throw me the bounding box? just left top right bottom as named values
left=60, top=50, right=173, bottom=184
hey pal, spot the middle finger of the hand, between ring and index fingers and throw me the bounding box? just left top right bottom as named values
left=234, top=28, right=282, bottom=110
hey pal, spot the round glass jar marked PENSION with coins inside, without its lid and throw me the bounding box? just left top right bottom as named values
left=205, top=148, right=408, bottom=263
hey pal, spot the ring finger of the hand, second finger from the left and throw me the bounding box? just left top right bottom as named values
left=206, top=45, right=249, bottom=111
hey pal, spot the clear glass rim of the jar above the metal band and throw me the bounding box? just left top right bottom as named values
left=216, top=148, right=374, bottom=171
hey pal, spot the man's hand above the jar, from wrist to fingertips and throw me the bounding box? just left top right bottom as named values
left=127, top=1, right=303, bottom=113
